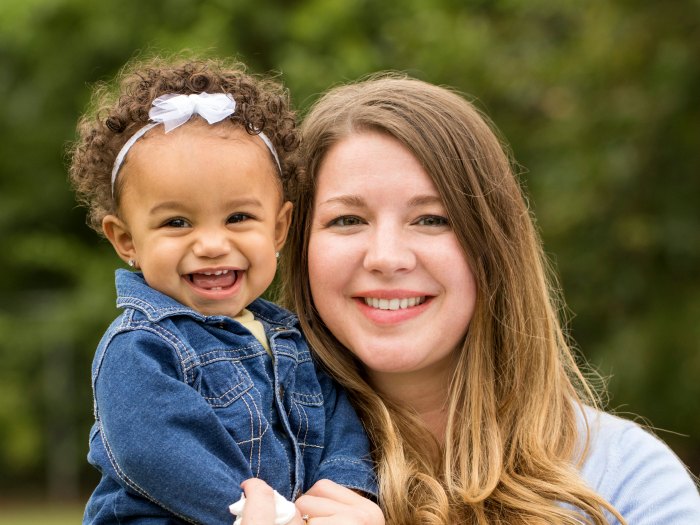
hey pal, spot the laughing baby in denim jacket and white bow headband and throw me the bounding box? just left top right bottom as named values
left=70, top=59, right=377, bottom=524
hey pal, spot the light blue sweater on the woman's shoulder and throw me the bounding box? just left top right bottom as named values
left=581, top=409, right=700, bottom=525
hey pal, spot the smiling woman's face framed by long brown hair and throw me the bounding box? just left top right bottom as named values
left=309, top=132, right=476, bottom=386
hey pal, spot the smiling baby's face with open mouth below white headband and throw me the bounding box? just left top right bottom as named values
left=113, top=121, right=291, bottom=317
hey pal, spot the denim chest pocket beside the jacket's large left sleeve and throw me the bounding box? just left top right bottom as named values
left=199, top=358, right=253, bottom=408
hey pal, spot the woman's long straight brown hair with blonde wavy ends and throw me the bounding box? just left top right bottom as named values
left=282, top=74, right=624, bottom=525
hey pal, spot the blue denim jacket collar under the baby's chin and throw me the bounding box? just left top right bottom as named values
left=115, top=269, right=298, bottom=328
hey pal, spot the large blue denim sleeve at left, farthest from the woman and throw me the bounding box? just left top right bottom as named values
left=93, top=325, right=253, bottom=524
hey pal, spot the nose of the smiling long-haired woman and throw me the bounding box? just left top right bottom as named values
left=364, top=225, right=416, bottom=275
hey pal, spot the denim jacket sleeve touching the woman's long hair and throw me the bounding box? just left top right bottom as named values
left=310, top=369, right=378, bottom=497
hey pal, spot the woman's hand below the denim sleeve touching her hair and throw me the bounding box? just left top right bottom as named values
left=294, top=479, right=384, bottom=525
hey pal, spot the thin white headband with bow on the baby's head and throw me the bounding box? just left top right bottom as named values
left=112, top=93, right=282, bottom=193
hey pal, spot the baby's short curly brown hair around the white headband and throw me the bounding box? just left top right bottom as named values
left=69, top=57, right=300, bottom=235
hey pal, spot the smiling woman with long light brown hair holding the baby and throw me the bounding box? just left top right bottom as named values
left=244, top=75, right=700, bottom=525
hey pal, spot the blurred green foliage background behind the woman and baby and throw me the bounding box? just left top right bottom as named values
left=0, top=0, right=700, bottom=524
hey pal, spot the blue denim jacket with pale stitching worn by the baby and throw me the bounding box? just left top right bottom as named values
left=83, top=270, right=377, bottom=524
